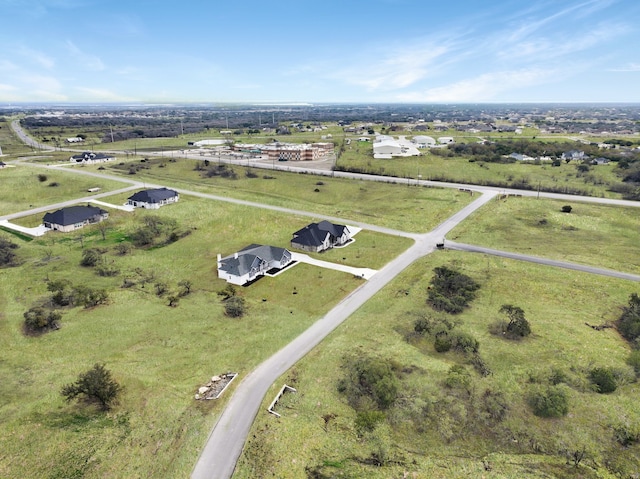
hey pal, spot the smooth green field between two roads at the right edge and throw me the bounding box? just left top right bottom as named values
left=448, top=197, right=640, bottom=274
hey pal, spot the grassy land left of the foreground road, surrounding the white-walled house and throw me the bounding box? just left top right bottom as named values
left=0, top=196, right=411, bottom=478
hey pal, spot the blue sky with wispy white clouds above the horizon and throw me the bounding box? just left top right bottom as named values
left=0, top=0, right=640, bottom=103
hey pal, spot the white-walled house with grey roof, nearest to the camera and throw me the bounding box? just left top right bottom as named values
left=218, top=244, right=293, bottom=286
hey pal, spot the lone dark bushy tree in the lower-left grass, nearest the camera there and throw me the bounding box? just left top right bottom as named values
left=60, top=363, right=122, bottom=411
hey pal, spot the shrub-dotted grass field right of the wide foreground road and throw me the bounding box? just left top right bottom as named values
left=234, top=251, right=640, bottom=479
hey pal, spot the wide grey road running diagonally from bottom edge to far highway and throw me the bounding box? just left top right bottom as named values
left=191, top=193, right=495, bottom=479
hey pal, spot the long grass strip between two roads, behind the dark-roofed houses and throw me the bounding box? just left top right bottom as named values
left=77, top=159, right=474, bottom=232
